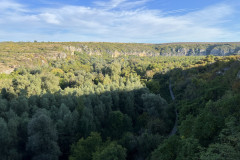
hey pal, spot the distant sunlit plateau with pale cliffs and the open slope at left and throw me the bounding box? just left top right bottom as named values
left=0, top=42, right=240, bottom=73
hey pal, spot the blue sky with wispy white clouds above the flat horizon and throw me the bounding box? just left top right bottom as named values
left=0, top=0, right=240, bottom=43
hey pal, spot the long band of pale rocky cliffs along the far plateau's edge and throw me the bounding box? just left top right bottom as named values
left=63, top=43, right=240, bottom=57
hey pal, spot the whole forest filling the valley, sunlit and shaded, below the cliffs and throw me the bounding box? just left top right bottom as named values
left=0, top=42, right=240, bottom=160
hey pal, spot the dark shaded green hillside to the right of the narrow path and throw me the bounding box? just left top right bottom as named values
left=150, top=57, right=240, bottom=160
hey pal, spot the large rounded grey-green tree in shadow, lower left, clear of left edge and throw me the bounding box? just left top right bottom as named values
left=27, top=110, right=60, bottom=160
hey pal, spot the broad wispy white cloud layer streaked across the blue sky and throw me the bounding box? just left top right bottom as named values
left=0, top=0, right=239, bottom=43
